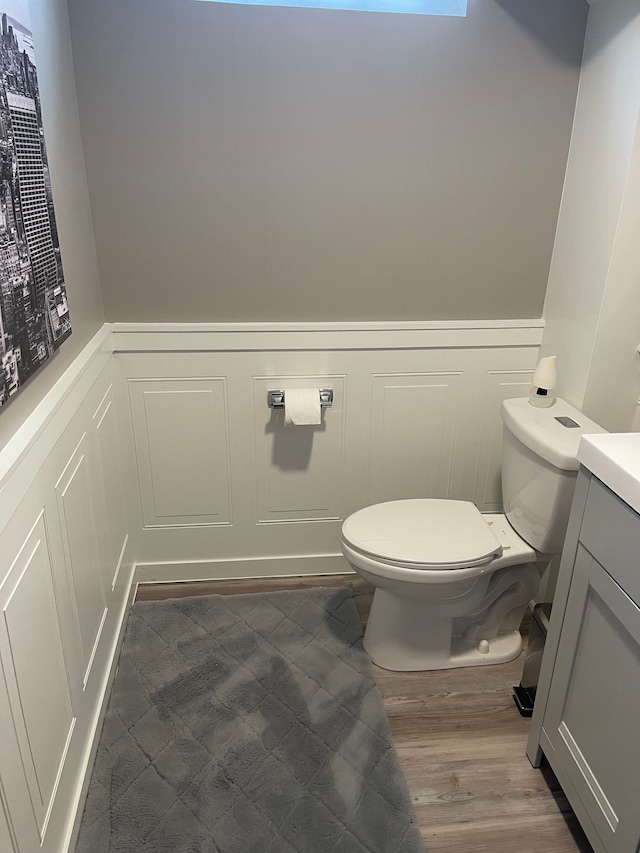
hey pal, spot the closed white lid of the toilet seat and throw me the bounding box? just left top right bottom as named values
left=342, top=498, right=502, bottom=568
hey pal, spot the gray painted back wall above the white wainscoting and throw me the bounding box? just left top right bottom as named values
left=69, top=0, right=588, bottom=321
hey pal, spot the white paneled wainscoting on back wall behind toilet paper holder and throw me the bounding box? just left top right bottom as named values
left=114, top=321, right=542, bottom=581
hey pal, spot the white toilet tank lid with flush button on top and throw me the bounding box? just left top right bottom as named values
left=500, top=397, right=607, bottom=471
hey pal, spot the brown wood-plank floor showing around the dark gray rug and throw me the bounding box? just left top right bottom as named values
left=137, top=575, right=592, bottom=853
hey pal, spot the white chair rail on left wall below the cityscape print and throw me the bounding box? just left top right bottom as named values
left=0, top=323, right=113, bottom=500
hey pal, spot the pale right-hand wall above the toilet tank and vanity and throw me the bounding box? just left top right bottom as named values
left=542, top=0, right=640, bottom=432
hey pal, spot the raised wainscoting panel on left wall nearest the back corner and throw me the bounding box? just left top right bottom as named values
left=93, top=385, right=126, bottom=591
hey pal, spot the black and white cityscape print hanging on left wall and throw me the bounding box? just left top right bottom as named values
left=0, top=0, right=71, bottom=406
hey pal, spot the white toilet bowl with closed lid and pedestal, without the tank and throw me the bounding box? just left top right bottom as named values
left=342, top=499, right=547, bottom=671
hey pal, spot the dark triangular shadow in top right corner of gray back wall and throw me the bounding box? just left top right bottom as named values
left=490, top=0, right=592, bottom=67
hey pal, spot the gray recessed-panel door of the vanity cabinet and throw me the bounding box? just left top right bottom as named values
left=543, top=545, right=640, bottom=853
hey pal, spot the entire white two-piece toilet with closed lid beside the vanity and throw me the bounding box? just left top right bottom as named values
left=342, top=398, right=606, bottom=671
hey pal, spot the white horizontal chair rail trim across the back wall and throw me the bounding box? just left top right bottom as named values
left=113, top=319, right=544, bottom=353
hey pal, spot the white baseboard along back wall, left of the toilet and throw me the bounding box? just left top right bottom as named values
left=134, top=554, right=353, bottom=583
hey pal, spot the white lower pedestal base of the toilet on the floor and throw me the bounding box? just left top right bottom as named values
left=364, top=589, right=522, bottom=672
